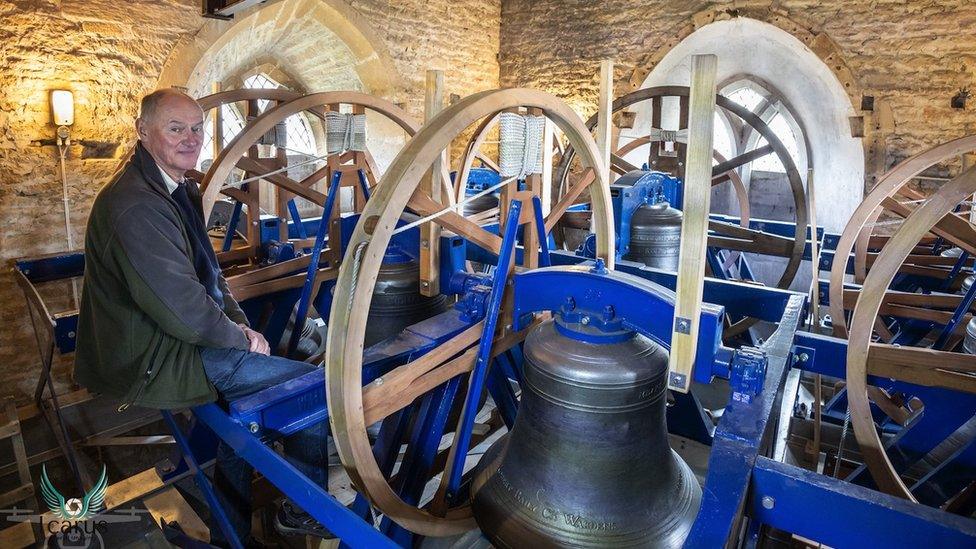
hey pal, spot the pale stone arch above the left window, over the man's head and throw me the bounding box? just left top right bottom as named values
left=158, top=0, right=403, bottom=100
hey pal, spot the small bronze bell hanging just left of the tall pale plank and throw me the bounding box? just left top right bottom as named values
left=624, top=202, right=682, bottom=272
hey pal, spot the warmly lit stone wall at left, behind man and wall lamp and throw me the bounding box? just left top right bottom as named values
left=0, top=0, right=501, bottom=400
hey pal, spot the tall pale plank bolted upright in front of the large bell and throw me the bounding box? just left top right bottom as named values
left=668, top=55, right=718, bottom=393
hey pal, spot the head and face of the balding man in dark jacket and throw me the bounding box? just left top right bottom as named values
left=138, top=95, right=203, bottom=181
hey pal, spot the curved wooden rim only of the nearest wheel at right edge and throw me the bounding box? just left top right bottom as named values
left=847, top=162, right=976, bottom=501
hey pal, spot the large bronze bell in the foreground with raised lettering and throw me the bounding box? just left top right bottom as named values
left=472, top=317, right=701, bottom=547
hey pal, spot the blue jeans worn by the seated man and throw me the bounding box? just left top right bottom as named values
left=200, top=347, right=329, bottom=546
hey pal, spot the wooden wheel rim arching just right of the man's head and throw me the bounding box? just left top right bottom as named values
left=200, top=90, right=418, bottom=219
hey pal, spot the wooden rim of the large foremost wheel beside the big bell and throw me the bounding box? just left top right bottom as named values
left=326, top=89, right=613, bottom=536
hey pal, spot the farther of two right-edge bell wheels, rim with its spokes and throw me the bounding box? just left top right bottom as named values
left=830, top=135, right=976, bottom=337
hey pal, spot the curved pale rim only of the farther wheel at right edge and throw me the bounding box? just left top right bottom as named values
left=830, top=135, right=976, bottom=337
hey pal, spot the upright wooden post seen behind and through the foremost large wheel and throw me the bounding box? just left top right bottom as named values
left=419, top=71, right=446, bottom=297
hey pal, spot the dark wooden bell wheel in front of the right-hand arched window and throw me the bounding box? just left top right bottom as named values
left=556, top=86, right=808, bottom=337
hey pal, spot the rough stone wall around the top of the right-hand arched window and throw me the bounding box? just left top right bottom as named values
left=499, top=0, right=976, bottom=169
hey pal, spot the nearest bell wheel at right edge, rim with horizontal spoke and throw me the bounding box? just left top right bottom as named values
left=844, top=162, right=976, bottom=501
